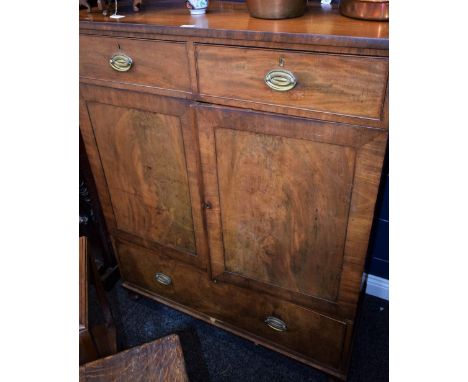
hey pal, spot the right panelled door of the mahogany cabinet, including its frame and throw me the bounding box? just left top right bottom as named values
left=195, top=104, right=387, bottom=318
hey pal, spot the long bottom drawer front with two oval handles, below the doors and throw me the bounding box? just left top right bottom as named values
left=117, top=241, right=346, bottom=370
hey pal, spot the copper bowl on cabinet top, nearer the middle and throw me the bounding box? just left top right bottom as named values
left=246, top=0, right=307, bottom=19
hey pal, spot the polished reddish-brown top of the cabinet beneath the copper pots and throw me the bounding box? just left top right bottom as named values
left=80, top=0, right=389, bottom=50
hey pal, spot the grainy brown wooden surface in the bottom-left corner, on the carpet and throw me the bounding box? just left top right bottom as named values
left=80, top=334, right=188, bottom=382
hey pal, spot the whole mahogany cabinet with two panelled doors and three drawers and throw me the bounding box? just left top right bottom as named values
left=80, top=1, right=388, bottom=379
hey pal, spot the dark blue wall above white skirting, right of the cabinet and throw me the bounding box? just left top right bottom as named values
left=366, top=150, right=389, bottom=280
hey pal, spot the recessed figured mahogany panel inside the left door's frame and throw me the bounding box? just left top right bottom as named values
left=88, top=102, right=196, bottom=253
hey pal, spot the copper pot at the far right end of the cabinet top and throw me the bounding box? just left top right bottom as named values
left=340, top=0, right=389, bottom=21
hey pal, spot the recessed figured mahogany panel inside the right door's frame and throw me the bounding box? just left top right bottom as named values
left=216, top=129, right=355, bottom=300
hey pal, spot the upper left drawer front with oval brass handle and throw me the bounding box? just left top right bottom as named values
left=80, top=35, right=191, bottom=92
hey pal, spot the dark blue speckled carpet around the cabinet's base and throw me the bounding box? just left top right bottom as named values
left=89, top=282, right=388, bottom=382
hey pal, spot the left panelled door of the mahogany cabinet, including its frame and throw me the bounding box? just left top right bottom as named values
left=80, top=84, right=206, bottom=267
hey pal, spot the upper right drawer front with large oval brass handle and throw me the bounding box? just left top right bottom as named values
left=197, top=45, right=388, bottom=120
